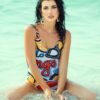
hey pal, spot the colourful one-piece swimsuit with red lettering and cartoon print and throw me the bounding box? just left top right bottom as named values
left=27, top=25, right=63, bottom=90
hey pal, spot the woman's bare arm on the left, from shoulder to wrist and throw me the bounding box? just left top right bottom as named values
left=24, top=26, right=51, bottom=93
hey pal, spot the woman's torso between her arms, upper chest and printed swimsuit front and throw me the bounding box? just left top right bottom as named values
left=27, top=23, right=63, bottom=88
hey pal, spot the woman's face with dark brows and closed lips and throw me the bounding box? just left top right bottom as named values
left=41, top=0, right=59, bottom=22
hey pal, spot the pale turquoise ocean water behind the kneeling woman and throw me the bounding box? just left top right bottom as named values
left=0, top=0, right=100, bottom=100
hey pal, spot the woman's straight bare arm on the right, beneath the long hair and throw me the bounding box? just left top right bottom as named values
left=56, top=31, right=71, bottom=94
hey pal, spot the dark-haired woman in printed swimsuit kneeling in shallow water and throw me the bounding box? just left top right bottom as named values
left=8, top=0, right=96, bottom=100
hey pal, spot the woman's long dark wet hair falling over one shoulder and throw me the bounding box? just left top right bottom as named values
left=36, top=0, right=66, bottom=42
